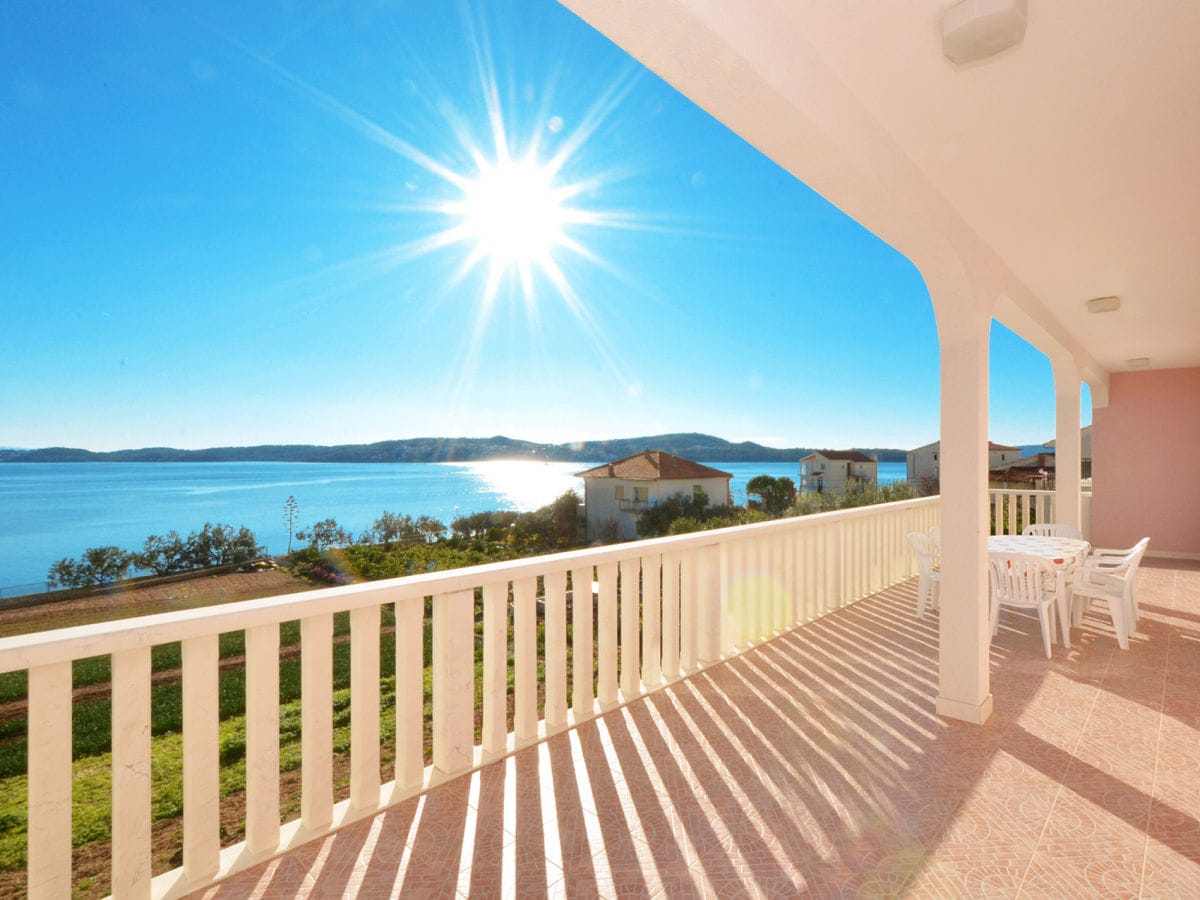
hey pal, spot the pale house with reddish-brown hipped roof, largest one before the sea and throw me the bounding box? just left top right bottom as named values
left=577, top=450, right=733, bottom=541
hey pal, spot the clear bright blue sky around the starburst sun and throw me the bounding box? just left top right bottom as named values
left=0, top=0, right=1090, bottom=450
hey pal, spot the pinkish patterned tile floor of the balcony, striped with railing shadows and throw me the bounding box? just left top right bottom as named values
left=194, top=560, right=1200, bottom=898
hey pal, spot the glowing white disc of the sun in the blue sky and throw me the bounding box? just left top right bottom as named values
left=446, top=157, right=566, bottom=272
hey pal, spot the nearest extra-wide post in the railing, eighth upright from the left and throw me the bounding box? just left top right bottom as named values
left=433, top=590, right=475, bottom=775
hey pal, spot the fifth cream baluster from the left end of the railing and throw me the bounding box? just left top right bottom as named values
left=300, top=613, right=334, bottom=832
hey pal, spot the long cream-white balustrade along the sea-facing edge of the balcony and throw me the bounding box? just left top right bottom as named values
left=0, top=491, right=936, bottom=896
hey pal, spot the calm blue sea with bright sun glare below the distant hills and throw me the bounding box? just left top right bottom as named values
left=0, top=461, right=905, bottom=598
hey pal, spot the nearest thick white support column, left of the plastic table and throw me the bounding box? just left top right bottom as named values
left=935, top=296, right=991, bottom=724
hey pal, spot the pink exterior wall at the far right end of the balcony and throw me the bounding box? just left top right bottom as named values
left=1092, top=368, right=1200, bottom=557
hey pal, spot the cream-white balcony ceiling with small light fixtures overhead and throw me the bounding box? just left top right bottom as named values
left=563, top=0, right=1200, bottom=374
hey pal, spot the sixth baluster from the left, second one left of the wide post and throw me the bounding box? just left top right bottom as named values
left=350, top=604, right=380, bottom=810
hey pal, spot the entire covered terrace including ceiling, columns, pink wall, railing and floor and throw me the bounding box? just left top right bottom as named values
left=0, top=0, right=1200, bottom=896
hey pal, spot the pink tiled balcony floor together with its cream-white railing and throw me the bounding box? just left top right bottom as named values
left=0, top=498, right=1200, bottom=898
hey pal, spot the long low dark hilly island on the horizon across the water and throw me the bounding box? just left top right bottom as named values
left=0, top=433, right=907, bottom=462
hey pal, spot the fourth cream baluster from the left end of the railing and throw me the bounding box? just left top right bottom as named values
left=244, top=623, right=280, bottom=854
